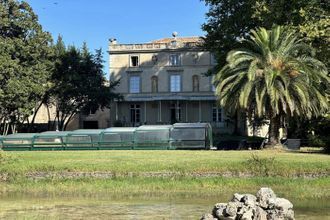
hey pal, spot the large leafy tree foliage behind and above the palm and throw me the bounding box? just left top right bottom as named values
left=202, top=0, right=330, bottom=70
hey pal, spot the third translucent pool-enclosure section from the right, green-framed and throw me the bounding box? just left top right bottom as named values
left=99, top=127, right=136, bottom=150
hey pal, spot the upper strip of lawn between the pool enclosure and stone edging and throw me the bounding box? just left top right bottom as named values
left=0, top=150, right=330, bottom=176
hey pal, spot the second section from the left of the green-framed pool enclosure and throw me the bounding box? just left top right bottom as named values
left=33, top=131, right=70, bottom=150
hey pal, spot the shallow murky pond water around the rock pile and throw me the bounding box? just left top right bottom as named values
left=0, top=195, right=330, bottom=220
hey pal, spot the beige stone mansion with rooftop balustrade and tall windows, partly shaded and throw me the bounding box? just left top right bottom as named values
left=109, top=34, right=245, bottom=133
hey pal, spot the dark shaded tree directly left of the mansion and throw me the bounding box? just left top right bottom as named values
left=45, top=37, right=120, bottom=130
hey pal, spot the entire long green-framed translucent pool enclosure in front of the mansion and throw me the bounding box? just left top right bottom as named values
left=0, top=123, right=213, bottom=150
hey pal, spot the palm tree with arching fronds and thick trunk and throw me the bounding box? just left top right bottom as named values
left=213, top=26, right=330, bottom=145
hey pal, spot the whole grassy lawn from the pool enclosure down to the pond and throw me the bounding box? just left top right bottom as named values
left=0, top=150, right=330, bottom=198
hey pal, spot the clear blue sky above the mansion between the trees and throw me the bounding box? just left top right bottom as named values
left=26, top=0, right=207, bottom=75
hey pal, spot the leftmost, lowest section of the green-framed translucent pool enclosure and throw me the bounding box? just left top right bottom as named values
left=2, top=133, right=36, bottom=150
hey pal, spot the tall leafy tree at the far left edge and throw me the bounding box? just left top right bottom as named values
left=0, top=0, right=53, bottom=133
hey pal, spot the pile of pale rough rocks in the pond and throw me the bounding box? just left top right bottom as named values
left=201, top=188, right=294, bottom=220
